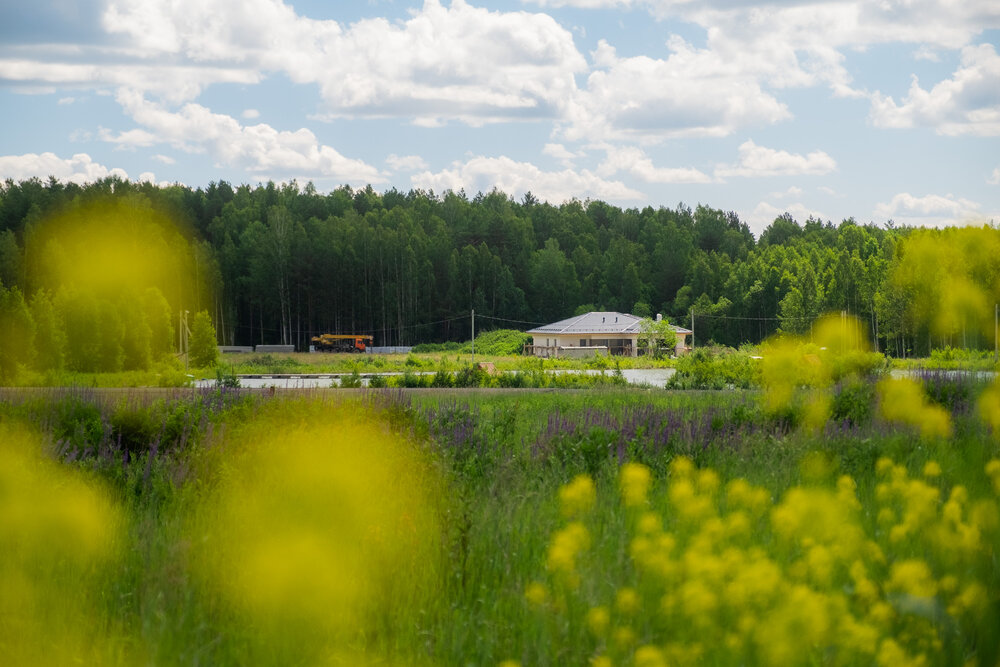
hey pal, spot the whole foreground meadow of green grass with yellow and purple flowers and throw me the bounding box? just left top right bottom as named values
left=0, top=378, right=1000, bottom=665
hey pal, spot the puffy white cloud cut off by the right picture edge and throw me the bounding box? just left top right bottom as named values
left=871, top=44, right=1000, bottom=137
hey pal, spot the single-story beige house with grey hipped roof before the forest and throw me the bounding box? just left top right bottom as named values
left=527, top=312, right=694, bottom=357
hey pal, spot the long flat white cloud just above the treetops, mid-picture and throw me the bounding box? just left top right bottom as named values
left=411, top=156, right=645, bottom=203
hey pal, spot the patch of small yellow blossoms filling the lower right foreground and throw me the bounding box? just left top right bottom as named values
left=524, top=454, right=1000, bottom=667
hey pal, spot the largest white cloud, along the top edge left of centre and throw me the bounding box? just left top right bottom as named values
left=104, top=0, right=586, bottom=125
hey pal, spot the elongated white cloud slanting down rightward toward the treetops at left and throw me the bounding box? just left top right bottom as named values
left=101, top=90, right=386, bottom=184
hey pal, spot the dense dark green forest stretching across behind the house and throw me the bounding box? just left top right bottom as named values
left=0, top=178, right=1000, bottom=365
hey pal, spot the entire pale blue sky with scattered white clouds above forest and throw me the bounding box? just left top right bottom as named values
left=0, top=0, right=1000, bottom=232
